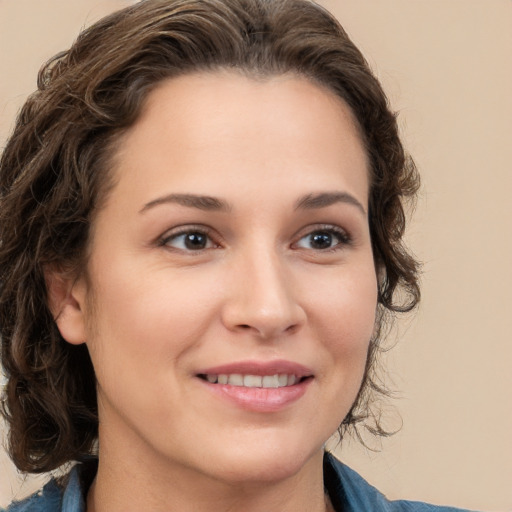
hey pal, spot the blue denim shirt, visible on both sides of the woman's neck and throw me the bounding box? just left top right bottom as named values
left=3, top=453, right=476, bottom=512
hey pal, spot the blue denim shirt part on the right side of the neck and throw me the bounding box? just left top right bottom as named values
left=324, top=453, right=478, bottom=512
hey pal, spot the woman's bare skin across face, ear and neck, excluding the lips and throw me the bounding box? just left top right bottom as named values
left=50, top=71, right=377, bottom=512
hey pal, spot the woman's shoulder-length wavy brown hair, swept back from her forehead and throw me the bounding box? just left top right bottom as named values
left=0, top=0, right=419, bottom=472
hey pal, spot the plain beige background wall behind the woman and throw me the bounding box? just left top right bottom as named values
left=0, top=0, right=512, bottom=511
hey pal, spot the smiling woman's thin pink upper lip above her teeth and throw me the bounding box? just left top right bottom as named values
left=197, top=360, right=313, bottom=378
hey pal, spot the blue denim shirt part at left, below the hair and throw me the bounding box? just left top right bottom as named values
left=1, top=464, right=85, bottom=512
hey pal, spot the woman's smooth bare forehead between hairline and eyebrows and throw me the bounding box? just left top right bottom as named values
left=108, top=71, right=368, bottom=208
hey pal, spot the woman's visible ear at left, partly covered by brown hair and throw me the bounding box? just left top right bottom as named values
left=44, top=269, right=86, bottom=345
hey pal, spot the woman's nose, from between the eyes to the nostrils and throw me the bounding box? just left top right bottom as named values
left=222, top=250, right=306, bottom=339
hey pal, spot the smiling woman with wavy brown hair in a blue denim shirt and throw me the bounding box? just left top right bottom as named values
left=0, top=0, right=472, bottom=512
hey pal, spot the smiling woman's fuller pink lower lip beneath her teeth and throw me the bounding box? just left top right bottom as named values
left=201, top=378, right=313, bottom=412
